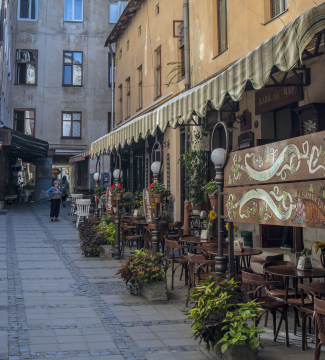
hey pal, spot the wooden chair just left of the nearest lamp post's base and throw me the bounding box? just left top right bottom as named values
left=186, top=254, right=216, bottom=306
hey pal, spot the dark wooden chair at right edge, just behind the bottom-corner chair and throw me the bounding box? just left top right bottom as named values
left=298, top=281, right=325, bottom=350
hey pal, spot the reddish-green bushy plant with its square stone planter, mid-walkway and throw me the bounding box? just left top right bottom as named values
left=116, top=250, right=168, bottom=301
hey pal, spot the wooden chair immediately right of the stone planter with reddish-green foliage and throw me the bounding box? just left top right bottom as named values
left=165, top=239, right=189, bottom=290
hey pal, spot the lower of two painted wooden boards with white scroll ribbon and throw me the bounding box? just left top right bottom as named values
left=224, top=180, right=325, bottom=229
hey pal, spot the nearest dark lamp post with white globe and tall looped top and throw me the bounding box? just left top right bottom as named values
left=211, top=121, right=234, bottom=277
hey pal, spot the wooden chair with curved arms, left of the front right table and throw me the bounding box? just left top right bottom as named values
left=242, top=271, right=289, bottom=346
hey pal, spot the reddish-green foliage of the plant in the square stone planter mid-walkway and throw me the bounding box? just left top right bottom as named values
left=116, top=250, right=168, bottom=295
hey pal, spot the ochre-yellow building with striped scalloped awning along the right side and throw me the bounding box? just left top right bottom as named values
left=91, top=0, right=325, bottom=252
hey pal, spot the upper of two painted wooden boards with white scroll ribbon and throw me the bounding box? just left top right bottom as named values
left=224, top=131, right=325, bottom=187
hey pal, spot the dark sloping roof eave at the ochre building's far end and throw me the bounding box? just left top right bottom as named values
left=105, top=0, right=146, bottom=47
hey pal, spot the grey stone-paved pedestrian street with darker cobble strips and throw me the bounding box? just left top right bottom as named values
left=0, top=203, right=314, bottom=360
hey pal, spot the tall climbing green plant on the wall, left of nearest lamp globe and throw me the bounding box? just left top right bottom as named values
left=179, top=130, right=207, bottom=205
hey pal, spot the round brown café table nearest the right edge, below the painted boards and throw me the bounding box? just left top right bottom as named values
left=265, top=265, right=325, bottom=300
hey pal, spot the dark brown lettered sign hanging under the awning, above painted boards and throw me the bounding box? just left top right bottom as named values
left=255, top=76, right=304, bottom=115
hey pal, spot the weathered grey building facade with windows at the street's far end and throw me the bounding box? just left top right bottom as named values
left=1, top=0, right=127, bottom=197
